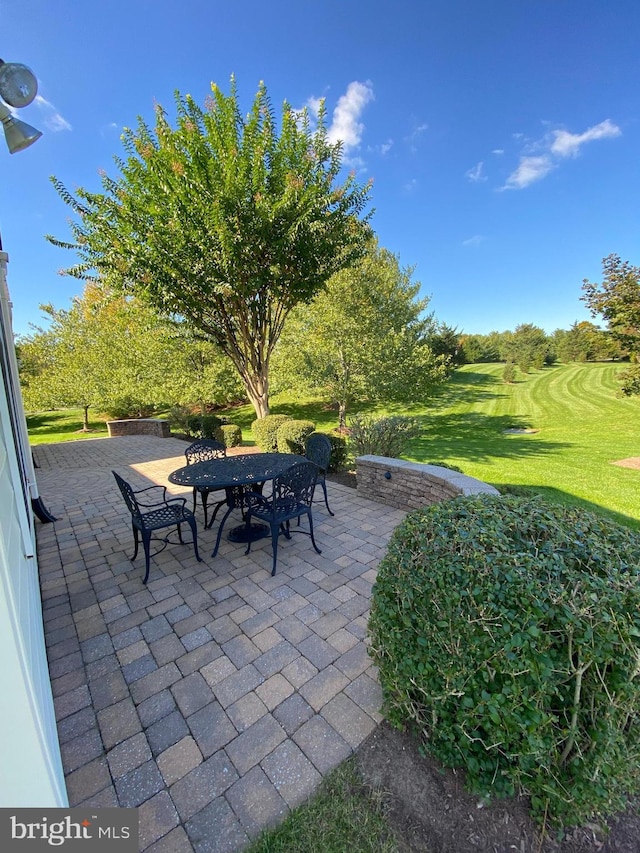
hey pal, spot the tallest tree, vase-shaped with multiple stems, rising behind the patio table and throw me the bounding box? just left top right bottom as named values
left=48, top=79, right=370, bottom=417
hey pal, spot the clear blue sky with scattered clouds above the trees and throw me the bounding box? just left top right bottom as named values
left=0, top=0, right=640, bottom=334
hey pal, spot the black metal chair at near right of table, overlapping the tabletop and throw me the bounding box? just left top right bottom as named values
left=245, top=461, right=322, bottom=575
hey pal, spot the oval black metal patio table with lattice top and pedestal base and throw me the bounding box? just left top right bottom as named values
left=169, top=453, right=304, bottom=557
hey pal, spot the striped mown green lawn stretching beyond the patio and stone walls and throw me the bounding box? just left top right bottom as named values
left=27, top=364, right=640, bottom=528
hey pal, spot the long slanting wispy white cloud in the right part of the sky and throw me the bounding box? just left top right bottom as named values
left=501, top=119, right=622, bottom=190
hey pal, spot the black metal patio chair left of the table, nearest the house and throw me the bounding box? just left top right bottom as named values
left=111, top=471, right=202, bottom=584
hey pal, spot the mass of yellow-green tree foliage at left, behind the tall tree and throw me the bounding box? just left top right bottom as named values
left=18, top=284, right=242, bottom=422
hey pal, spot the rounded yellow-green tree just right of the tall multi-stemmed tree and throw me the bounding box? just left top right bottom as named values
left=274, top=240, right=449, bottom=427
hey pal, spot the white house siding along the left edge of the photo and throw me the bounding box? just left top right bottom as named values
left=0, top=252, right=68, bottom=808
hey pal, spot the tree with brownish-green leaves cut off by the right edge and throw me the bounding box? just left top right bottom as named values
left=582, top=255, right=640, bottom=355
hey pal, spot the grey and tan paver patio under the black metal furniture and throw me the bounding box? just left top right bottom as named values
left=34, top=436, right=404, bottom=853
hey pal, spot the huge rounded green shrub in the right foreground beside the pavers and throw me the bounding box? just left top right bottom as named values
left=369, top=495, right=640, bottom=825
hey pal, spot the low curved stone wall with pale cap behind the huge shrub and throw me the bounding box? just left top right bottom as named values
left=356, top=456, right=500, bottom=510
